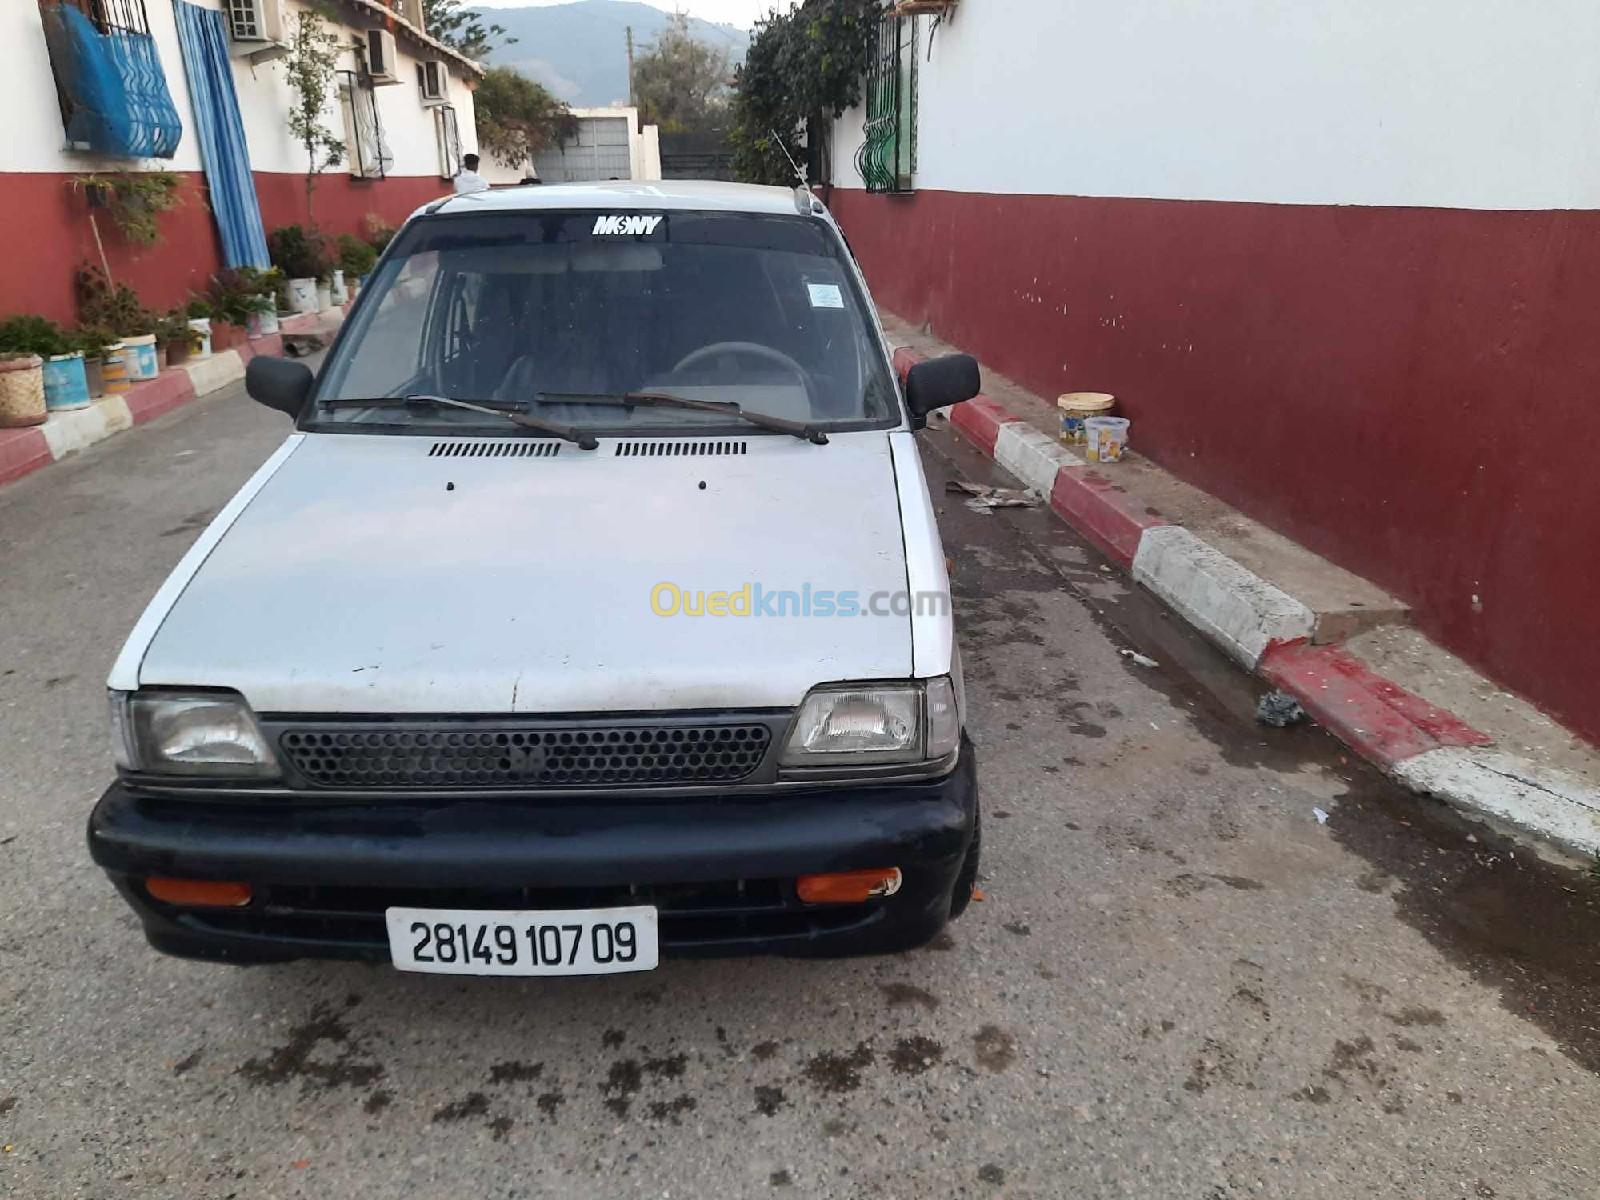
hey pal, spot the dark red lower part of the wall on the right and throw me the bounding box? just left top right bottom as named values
left=830, top=190, right=1600, bottom=741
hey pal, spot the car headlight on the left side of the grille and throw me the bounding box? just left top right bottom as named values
left=110, top=691, right=278, bottom=779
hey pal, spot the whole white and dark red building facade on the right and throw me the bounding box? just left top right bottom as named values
left=830, top=0, right=1600, bottom=739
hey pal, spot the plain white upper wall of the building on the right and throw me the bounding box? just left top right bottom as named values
left=834, top=0, right=1600, bottom=208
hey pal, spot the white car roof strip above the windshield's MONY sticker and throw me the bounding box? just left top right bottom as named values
left=422, top=179, right=821, bottom=216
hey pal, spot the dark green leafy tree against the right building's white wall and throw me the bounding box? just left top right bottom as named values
left=728, top=0, right=883, bottom=184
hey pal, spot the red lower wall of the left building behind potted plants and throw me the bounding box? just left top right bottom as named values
left=0, top=171, right=450, bottom=323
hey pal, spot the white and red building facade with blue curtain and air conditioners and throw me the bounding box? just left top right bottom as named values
left=0, top=0, right=480, bottom=322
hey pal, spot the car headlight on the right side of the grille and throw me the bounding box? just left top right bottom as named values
left=782, top=677, right=962, bottom=766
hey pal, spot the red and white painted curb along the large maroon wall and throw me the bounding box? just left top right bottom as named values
left=894, top=347, right=1600, bottom=856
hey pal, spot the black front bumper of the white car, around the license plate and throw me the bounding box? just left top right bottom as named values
left=88, top=744, right=978, bottom=963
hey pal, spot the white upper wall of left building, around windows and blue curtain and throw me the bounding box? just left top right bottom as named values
left=0, top=0, right=477, bottom=178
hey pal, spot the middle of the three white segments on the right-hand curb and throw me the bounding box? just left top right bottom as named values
left=1133, top=525, right=1317, bottom=670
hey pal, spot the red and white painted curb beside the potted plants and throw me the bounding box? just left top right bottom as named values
left=0, top=307, right=344, bottom=496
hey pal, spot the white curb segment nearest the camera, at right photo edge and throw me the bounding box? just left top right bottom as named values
left=1394, top=746, right=1600, bottom=856
